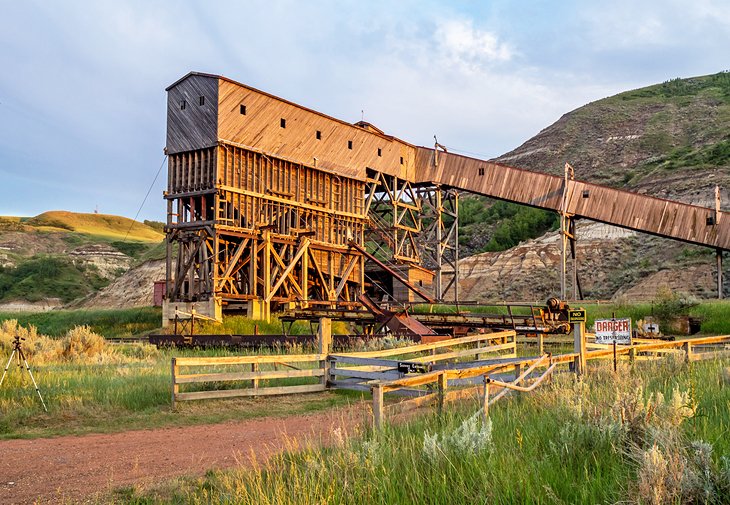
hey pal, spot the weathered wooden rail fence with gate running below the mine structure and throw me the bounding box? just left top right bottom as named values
left=172, top=319, right=730, bottom=420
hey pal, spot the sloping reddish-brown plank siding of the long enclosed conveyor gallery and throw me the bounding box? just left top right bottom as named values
left=416, top=148, right=730, bottom=250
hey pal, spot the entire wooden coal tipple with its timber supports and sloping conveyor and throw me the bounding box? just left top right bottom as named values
left=163, top=72, right=730, bottom=321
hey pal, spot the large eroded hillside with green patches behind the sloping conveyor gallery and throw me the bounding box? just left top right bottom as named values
left=459, top=72, right=730, bottom=299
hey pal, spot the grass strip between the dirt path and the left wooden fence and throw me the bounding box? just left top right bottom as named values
left=0, top=336, right=353, bottom=438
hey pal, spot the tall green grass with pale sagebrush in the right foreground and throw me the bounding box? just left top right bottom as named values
left=121, top=360, right=730, bottom=504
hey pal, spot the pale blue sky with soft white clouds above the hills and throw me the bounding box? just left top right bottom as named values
left=0, top=0, right=730, bottom=220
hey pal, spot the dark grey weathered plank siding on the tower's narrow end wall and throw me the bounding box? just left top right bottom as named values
left=166, top=75, right=218, bottom=154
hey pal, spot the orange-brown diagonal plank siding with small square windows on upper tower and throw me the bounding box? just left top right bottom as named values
left=218, top=79, right=415, bottom=180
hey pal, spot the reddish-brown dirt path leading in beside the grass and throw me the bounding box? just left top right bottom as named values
left=0, top=408, right=363, bottom=503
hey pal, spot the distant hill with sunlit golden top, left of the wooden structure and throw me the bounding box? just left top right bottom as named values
left=0, top=211, right=165, bottom=306
